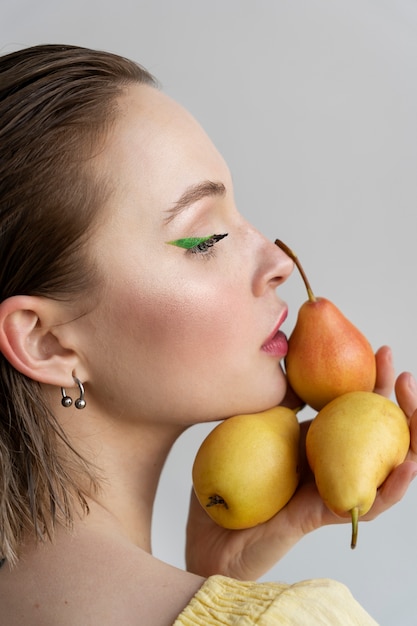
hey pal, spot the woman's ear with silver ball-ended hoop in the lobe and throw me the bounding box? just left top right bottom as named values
left=0, top=296, right=78, bottom=387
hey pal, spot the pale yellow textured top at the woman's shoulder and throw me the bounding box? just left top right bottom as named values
left=173, top=576, right=377, bottom=626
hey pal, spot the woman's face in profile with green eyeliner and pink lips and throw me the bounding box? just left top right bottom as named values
left=79, top=85, right=292, bottom=424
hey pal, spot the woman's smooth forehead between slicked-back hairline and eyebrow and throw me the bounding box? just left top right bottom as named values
left=94, top=85, right=231, bottom=233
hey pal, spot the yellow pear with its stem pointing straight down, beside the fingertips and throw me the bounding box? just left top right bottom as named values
left=306, top=391, right=410, bottom=548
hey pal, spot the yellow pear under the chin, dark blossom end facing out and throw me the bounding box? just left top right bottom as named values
left=192, top=407, right=300, bottom=529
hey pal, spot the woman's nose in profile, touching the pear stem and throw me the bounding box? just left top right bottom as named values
left=253, top=236, right=294, bottom=296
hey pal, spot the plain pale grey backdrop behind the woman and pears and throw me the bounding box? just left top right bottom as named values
left=0, top=0, right=417, bottom=626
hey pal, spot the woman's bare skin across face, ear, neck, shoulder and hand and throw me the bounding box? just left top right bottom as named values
left=0, top=86, right=417, bottom=626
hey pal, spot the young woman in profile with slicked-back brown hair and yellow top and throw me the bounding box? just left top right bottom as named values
left=0, top=46, right=417, bottom=626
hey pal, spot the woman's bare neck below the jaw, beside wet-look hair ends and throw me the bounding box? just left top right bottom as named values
left=59, top=410, right=184, bottom=552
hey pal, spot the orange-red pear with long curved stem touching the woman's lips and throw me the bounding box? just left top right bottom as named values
left=275, top=239, right=376, bottom=411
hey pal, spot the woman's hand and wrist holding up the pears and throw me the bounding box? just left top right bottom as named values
left=186, top=347, right=417, bottom=580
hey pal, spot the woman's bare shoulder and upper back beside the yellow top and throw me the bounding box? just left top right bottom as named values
left=0, top=532, right=203, bottom=626
